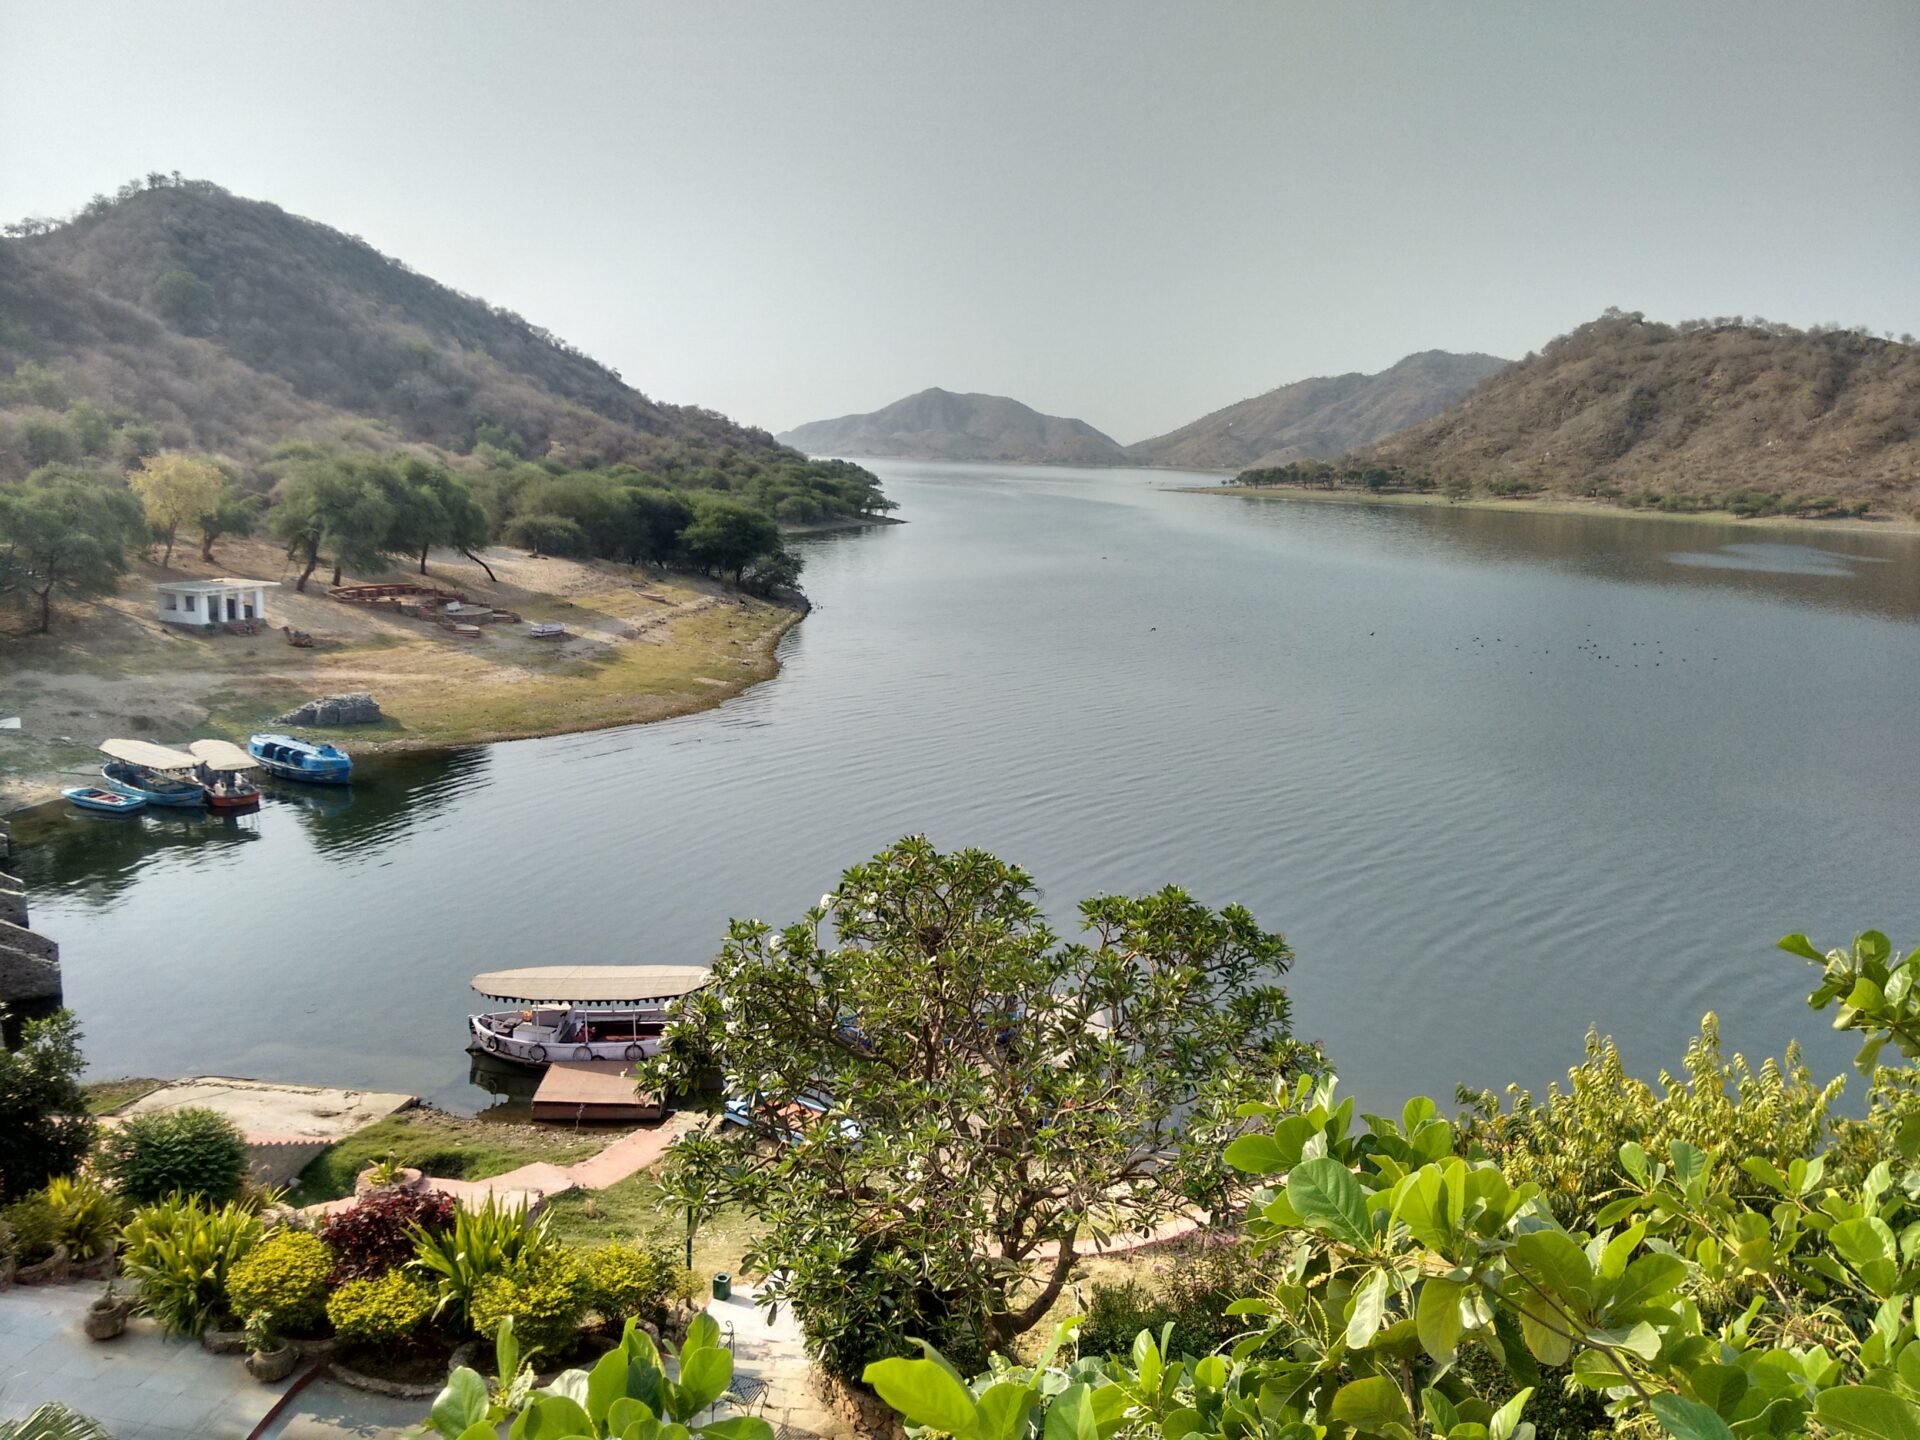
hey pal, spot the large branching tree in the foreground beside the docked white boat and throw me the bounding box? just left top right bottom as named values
left=651, top=837, right=1309, bottom=1377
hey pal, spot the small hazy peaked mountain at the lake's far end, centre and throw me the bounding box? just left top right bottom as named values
left=776, top=388, right=1125, bottom=465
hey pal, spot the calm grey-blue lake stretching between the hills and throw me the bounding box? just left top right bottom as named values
left=19, top=463, right=1920, bottom=1108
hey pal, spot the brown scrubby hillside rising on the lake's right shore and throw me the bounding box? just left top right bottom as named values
left=1361, top=311, right=1920, bottom=511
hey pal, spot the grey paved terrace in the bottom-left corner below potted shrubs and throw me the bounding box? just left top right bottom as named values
left=0, top=1283, right=428, bottom=1440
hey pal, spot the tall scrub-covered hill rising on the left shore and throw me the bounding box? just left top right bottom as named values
left=0, top=177, right=793, bottom=470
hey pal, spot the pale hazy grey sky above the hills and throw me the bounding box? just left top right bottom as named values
left=0, top=0, right=1920, bottom=442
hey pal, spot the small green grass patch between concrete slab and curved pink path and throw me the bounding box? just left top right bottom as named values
left=288, top=1108, right=599, bottom=1206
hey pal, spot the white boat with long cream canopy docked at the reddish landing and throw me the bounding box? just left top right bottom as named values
left=467, top=966, right=708, bottom=1066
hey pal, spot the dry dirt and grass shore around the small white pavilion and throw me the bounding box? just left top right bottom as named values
left=0, top=541, right=799, bottom=812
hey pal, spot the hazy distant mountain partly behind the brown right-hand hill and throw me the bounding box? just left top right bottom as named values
left=1127, top=349, right=1509, bottom=470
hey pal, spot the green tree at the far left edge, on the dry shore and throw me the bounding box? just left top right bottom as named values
left=0, top=465, right=146, bottom=636
